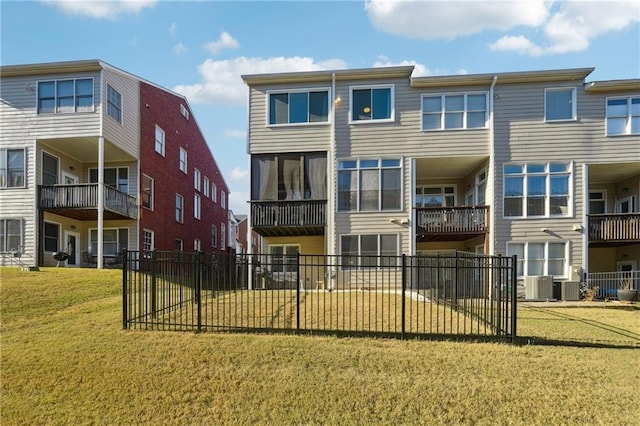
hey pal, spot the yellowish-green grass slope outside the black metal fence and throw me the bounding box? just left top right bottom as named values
left=0, top=268, right=640, bottom=426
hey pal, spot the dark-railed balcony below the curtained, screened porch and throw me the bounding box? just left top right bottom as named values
left=251, top=200, right=327, bottom=237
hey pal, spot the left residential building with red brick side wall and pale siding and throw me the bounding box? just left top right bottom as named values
left=0, top=60, right=228, bottom=267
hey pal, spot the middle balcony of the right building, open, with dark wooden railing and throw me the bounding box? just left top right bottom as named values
left=415, top=206, right=489, bottom=242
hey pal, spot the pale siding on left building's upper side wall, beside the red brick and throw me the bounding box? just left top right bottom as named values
left=102, top=69, right=140, bottom=158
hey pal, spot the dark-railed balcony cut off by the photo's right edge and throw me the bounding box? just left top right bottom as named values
left=588, top=213, right=640, bottom=247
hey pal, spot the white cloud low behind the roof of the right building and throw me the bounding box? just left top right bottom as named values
left=173, top=56, right=346, bottom=105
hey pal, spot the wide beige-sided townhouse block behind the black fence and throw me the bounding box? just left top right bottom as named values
left=243, top=66, right=640, bottom=288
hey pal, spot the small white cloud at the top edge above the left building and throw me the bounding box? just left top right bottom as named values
left=43, top=0, right=157, bottom=20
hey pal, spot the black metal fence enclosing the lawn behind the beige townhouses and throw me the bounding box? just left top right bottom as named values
left=122, top=251, right=516, bottom=340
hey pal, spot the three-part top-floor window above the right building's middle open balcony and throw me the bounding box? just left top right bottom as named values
left=422, top=93, right=488, bottom=130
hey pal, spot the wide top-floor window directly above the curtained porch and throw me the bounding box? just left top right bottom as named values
left=269, top=90, right=329, bottom=124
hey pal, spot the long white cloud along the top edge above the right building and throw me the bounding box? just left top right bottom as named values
left=364, top=0, right=550, bottom=40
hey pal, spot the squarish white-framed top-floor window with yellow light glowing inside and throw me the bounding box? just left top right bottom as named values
left=351, top=86, right=393, bottom=121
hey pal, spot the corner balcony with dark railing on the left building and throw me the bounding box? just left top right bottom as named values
left=38, top=183, right=138, bottom=220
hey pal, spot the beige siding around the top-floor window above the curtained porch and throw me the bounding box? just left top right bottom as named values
left=249, top=83, right=333, bottom=154
